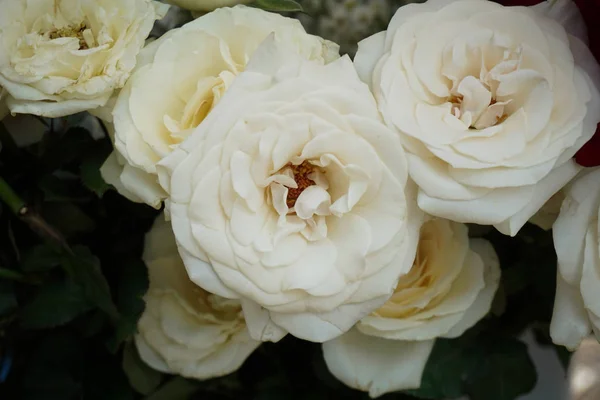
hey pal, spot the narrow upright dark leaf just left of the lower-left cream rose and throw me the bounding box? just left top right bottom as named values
left=108, top=259, right=149, bottom=352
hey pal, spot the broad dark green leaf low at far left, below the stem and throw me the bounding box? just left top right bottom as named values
left=21, top=281, right=92, bottom=329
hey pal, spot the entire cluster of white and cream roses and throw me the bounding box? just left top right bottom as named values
left=0, top=0, right=600, bottom=397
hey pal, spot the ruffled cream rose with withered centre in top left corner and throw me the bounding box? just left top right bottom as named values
left=0, top=0, right=168, bottom=117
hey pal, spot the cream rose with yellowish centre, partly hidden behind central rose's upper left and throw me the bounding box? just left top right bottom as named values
left=102, top=6, right=339, bottom=208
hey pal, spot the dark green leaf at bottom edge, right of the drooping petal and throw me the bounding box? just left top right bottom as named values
left=467, top=337, right=537, bottom=400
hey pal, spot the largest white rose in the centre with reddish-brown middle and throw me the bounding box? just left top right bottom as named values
left=159, top=37, right=420, bottom=342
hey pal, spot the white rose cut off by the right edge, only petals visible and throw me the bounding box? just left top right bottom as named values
left=550, top=168, right=600, bottom=350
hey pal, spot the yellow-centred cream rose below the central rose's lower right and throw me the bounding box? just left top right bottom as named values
left=323, top=219, right=500, bottom=397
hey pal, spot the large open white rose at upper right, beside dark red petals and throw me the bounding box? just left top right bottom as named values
left=355, top=0, right=600, bottom=235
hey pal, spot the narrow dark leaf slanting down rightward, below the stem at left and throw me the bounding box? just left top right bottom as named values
left=62, top=246, right=119, bottom=321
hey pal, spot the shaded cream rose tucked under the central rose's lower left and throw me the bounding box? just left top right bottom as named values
left=135, top=212, right=260, bottom=379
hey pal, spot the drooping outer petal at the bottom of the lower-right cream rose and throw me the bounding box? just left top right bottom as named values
left=323, top=329, right=435, bottom=398
